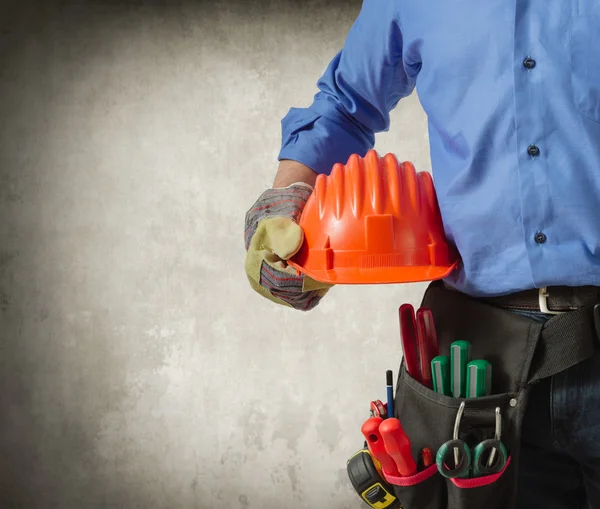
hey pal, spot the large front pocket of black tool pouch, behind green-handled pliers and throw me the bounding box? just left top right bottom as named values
left=388, top=364, right=524, bottom=509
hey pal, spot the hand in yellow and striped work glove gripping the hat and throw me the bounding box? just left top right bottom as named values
left=244, top=183, right=331, bottom=311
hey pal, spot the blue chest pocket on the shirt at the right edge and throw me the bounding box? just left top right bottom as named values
left=570, top=15, right=600, bottom=122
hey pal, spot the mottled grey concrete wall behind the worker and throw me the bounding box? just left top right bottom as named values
left=0, top=0, right=429, bottom=509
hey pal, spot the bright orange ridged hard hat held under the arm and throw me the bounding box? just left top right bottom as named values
left=289, top=150, right=459, bottom=284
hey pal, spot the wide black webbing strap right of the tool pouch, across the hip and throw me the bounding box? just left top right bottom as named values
left=528, top=305, right=600, bottom=382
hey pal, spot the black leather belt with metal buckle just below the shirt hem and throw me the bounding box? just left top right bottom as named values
left=442, top=286, right=600, bottom=313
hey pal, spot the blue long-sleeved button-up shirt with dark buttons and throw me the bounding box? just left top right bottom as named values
left=279, top=0, right=600, bottom=296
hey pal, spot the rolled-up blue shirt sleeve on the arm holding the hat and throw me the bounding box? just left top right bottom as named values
left=279, top=0, right=417, bottom=174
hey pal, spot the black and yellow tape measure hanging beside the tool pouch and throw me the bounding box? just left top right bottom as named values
left=346, top=449, right=402, bottom=509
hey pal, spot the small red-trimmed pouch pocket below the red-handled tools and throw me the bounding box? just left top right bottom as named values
left=385, top=464, right=448, bottom=509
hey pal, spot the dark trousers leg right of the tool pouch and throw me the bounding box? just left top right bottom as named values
left=517, top=313, right=600, bottom=509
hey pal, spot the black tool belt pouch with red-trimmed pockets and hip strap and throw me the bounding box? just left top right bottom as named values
left=386, top=282, right=596, bottom=509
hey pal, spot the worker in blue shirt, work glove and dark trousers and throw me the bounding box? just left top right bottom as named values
left=245, top=0, right=600, bottom=509
